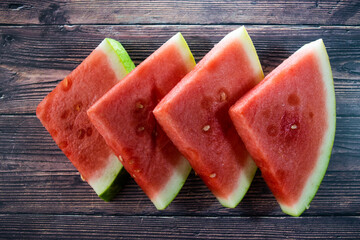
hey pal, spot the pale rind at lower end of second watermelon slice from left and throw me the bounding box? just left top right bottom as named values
left=151, top=155, right=191, bottom=210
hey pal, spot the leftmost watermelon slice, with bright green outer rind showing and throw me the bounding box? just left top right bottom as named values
left=36, top=38, right=135, bottom=201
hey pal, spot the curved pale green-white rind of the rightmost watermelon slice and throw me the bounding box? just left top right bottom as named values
left=279, top=39, right=336, bottom=217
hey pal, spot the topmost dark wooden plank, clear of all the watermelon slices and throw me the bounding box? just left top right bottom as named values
left=0, top=0, right=360, bottom=25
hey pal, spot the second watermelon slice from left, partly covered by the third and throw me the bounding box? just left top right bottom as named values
left=88, top=33, right=195, bottom=209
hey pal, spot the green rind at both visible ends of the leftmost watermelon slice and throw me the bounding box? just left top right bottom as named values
left=88, top=38, right=135, bottom=201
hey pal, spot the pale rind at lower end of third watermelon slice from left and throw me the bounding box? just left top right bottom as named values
left=216, top=155, right=257, bottom=208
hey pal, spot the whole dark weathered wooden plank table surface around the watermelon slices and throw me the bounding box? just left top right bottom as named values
left=0, top=0, right=360, bottom=239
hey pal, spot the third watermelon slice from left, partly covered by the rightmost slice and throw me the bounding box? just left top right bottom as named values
left=154, top=27, right=264, bottom=208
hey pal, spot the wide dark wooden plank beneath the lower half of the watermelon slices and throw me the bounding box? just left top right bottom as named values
left=0, top=115, right=360, bottom=216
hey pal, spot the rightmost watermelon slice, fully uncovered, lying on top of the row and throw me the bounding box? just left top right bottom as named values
left=230, top=39, right=336, bottom=216
